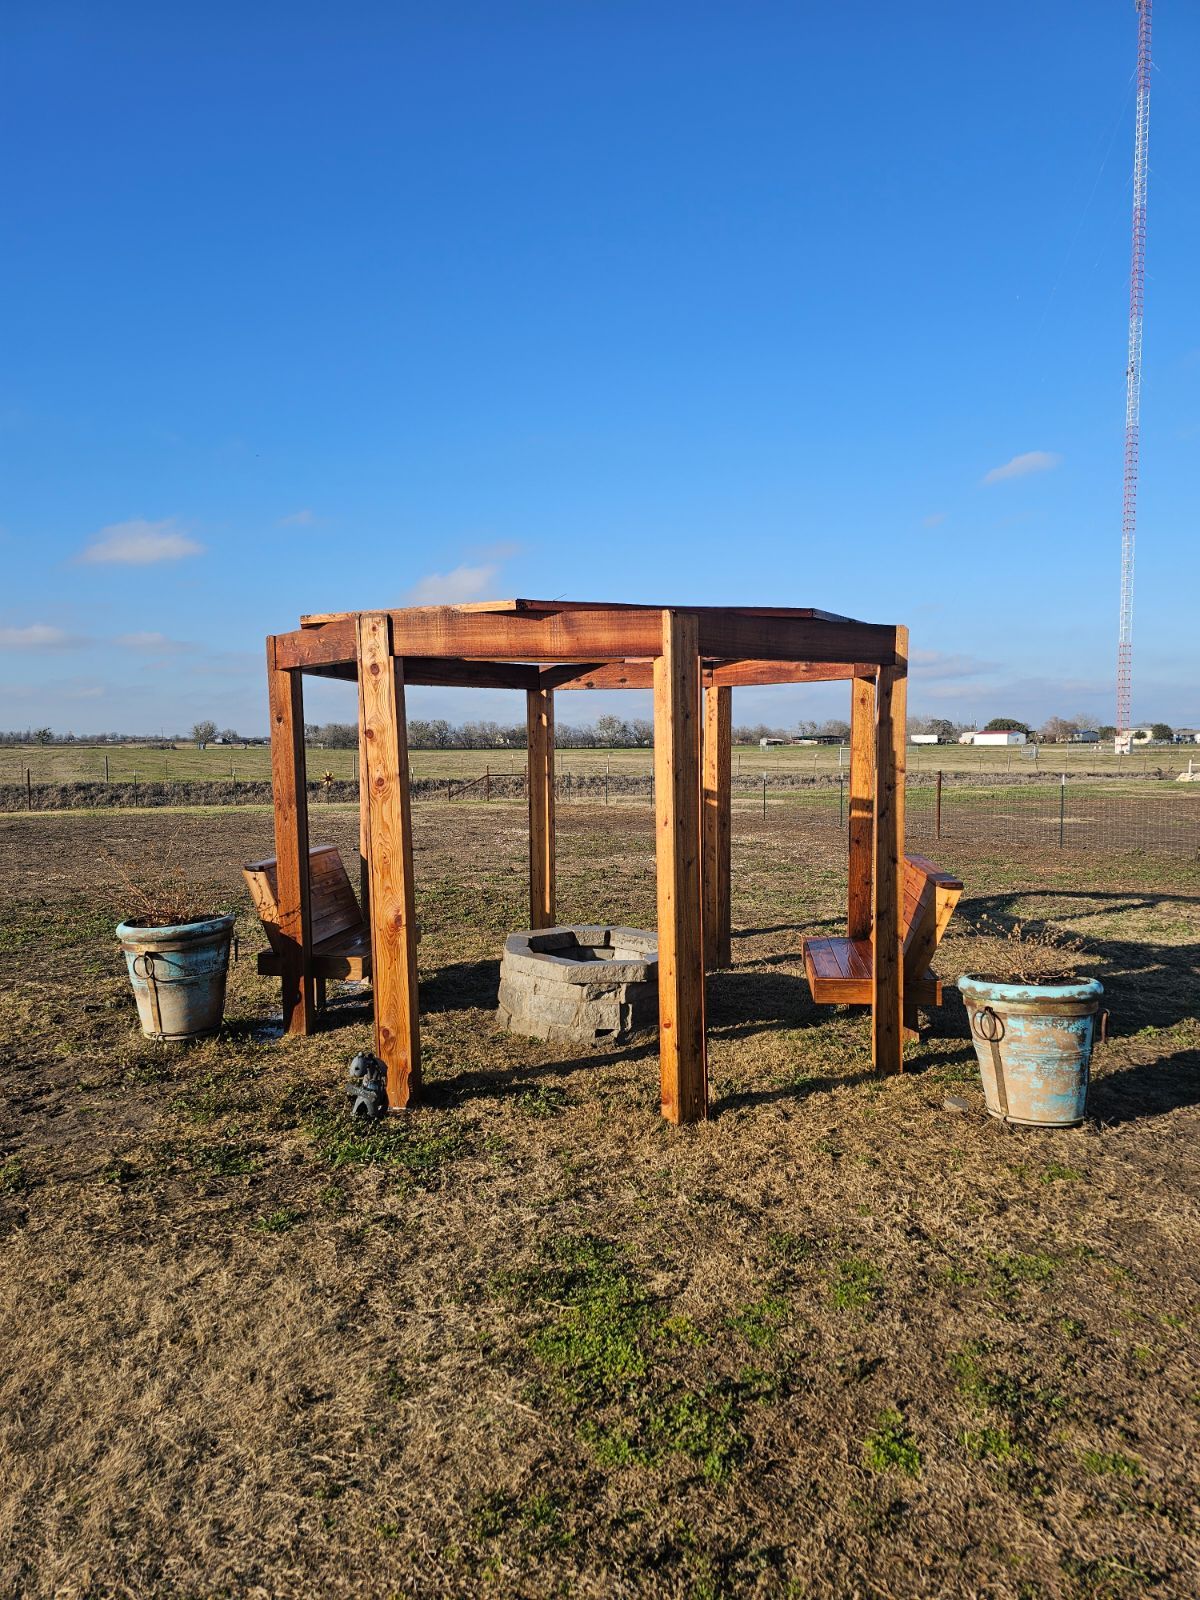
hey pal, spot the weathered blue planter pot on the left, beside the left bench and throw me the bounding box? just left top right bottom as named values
left=117, top=915, right=234, bottom=1038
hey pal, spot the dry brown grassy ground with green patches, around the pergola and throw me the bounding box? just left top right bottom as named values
left=0, top=805, right=1200, bottom=1600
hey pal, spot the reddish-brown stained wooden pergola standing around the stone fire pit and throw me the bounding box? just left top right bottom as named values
left=267, top=600, right=909, bottom=1122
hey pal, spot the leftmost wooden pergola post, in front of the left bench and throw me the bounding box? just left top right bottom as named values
left=267, top=638, right=317, bottom=1034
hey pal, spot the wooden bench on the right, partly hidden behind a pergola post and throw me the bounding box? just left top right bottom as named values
left=805, top=856, right=963, bottom=1030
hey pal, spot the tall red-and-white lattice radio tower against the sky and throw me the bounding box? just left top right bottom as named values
left=1115, top=0, right=1154, bottom=755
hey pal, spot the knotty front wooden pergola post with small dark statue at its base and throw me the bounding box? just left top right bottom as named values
left=355, top=611, right=421, bottom=1112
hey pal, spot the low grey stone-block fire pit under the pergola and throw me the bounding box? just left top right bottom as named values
left=498, top=926, right=658, bottom=1043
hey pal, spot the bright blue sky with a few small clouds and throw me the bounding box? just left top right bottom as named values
left=0, top=0, right=1200, bottom=733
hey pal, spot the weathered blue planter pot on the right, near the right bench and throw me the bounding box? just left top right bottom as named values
left=958, top=978, right=1107, bottom=1128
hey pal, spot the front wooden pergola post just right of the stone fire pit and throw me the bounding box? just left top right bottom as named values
left=654, top=611, right=709, bottom=1122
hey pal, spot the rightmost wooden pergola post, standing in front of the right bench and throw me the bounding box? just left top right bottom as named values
left=870, top=627, right=909, bottom=1072
